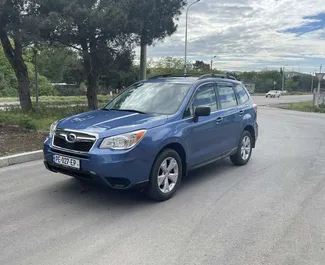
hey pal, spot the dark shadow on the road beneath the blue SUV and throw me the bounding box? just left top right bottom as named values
left=42, top=159, right=233, bottom=210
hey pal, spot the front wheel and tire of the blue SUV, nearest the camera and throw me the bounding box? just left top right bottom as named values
left=146, top=149, right=183, bottom=201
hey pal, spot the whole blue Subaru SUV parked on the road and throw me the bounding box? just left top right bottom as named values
left=44, top=75, right=258, bottom=201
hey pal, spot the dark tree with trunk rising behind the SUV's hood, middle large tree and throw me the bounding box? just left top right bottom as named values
left=34, top=0, right=134, bottom=109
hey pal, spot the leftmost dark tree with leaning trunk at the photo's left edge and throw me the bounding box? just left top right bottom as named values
left=0, top=0, right=35, bottom=111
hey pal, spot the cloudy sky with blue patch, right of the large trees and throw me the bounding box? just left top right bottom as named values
left=137, top=0, right=325, bottom=73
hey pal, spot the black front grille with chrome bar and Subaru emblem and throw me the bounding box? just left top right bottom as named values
left=53, top=130, right=96, bottom=153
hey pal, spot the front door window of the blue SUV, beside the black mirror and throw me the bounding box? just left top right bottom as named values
left=185, top=84, right=218, bottom=117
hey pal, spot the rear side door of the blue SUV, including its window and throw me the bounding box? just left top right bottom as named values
left=217, top=82, right=241, bottom=155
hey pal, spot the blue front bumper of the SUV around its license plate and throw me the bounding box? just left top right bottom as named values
left=43, top=138, right=154, bottom=189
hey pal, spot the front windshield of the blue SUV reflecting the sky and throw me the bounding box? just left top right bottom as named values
left=104, top=80, right=191, bottom=115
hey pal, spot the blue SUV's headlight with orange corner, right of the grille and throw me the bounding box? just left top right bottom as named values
left=100, top=130, right=147, bottom=150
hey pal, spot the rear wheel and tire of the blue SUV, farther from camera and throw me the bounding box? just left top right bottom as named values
left=230, top=131, right=253, bottom=166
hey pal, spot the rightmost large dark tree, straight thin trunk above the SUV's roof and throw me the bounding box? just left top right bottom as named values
left=129, top=0, right=186, bottom=79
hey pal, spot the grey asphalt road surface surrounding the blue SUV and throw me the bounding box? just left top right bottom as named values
left=0, top=98, right=325, bottom=265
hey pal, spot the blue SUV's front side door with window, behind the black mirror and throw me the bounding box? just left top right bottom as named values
left=185, top=82, right=221, bottom=166
